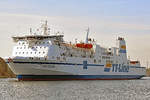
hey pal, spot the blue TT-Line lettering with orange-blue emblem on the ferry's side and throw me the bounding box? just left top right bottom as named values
left=104, top=64, right=129, bottom=72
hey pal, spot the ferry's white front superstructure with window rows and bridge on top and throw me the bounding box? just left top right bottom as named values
left=12, top=35, right=63, bottom=58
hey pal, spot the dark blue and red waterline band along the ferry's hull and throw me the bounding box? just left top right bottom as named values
left=17, top=75, right=144, bottom=81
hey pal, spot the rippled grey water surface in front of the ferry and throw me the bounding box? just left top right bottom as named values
left=0, top=77, right=150, bottom=100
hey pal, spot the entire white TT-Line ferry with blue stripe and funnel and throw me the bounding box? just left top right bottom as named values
left=5, top=21, right=146, bottom=81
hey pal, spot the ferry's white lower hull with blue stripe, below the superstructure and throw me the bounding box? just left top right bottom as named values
left=8, top=61, right=145, bottom=80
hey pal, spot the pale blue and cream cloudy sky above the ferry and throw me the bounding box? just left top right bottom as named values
left=0, top=0, right=150, bottom=66
